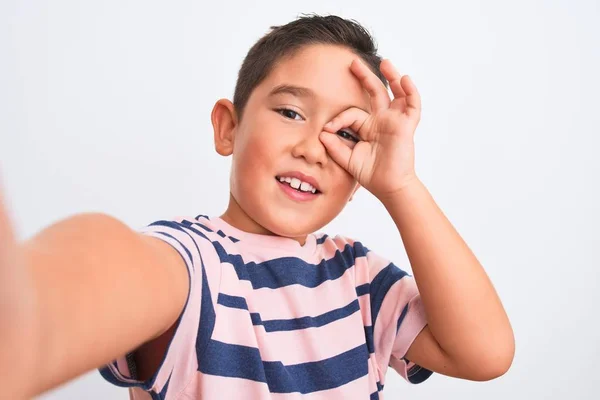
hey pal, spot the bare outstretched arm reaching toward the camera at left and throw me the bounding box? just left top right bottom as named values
left=0, top=193, right=188, bottom=399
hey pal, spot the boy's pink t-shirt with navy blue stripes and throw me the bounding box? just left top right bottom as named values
left=100, top=215, right=432, bottom=400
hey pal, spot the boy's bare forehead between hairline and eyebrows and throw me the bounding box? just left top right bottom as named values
left=255, top=45, right=369, bottom=111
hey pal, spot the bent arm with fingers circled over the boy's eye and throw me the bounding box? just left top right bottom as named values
left=321, top=59, right=515, bottom=380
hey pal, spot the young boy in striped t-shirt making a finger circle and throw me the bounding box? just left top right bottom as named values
left=0, top=16, right=514, bottom=399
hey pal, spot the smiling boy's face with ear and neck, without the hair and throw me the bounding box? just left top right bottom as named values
left=213, top=45, right=370, bottom=244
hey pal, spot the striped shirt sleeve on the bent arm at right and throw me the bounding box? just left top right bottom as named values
left=366, top=250, right=432, bottom=384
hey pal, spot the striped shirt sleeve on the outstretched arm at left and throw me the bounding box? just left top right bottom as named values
left=99, top=220, right=219, bottom=399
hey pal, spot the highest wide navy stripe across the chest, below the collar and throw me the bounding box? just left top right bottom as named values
left=214, top=239, right=366, bottom=289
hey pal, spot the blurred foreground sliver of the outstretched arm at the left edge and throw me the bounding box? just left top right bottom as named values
left=0, top=189, right=39, bottom=399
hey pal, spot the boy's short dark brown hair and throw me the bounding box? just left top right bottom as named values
left=233, top=14, right=388, bottom=120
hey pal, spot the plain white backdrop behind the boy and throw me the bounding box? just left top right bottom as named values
left=0, top=0, right=600, bottom=400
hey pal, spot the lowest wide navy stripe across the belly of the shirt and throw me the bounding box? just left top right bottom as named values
left=199, top=340, right=369, bottom=394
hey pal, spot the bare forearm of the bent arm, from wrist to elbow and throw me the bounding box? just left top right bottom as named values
left=383, top=178, right=514, bottom=365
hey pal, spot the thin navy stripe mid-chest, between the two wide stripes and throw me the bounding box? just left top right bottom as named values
left=251, top=300, right=360, bottom=332
